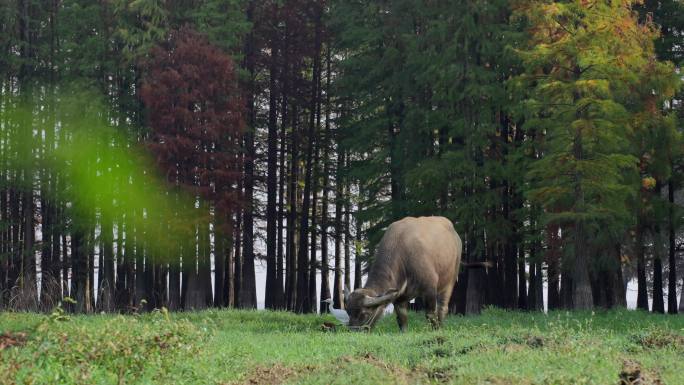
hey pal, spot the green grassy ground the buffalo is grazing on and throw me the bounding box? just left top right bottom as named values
left=0, top=309, right=684, bottom=384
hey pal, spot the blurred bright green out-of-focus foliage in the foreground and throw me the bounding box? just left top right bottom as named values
left=0, top=92, right=209, bottom=257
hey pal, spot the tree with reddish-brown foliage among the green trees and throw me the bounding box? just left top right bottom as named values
left=141, top=28, right=244, bottom=308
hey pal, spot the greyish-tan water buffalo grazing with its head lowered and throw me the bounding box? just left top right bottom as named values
left=345, top=217, right=464, bottom=331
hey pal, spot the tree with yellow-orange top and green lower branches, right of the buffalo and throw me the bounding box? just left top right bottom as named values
left=518, top=1, right=674, bottom=309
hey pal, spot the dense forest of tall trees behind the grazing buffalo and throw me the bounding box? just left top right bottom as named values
left=0, top=0, right=684, bottom=314
